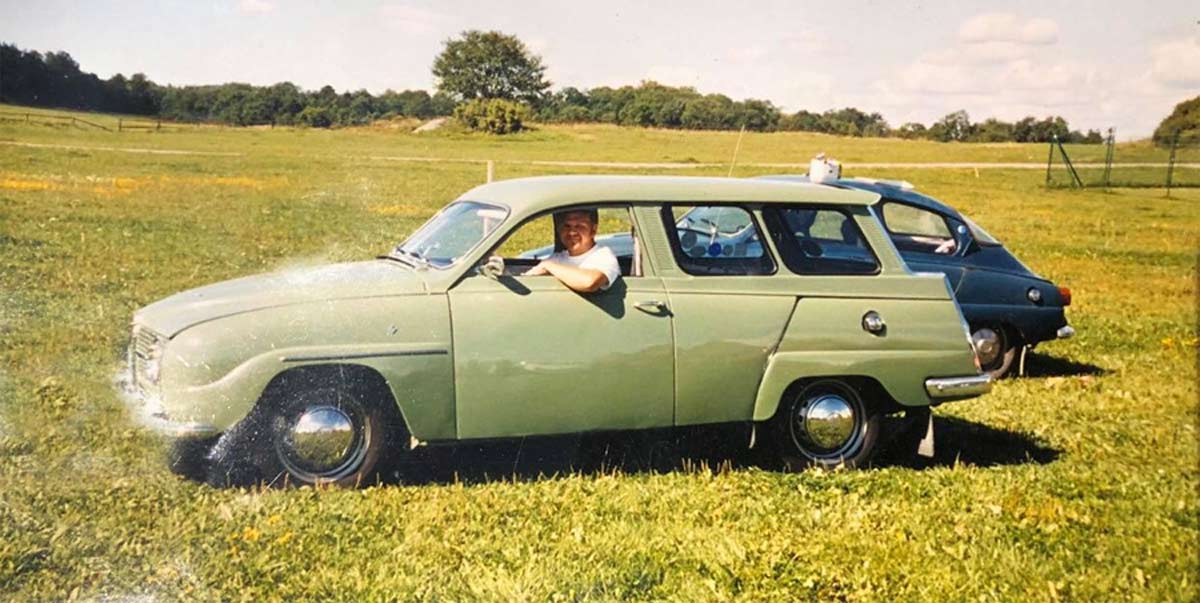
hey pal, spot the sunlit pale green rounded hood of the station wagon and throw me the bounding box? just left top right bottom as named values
left=133, top=259, right=428, bottom=338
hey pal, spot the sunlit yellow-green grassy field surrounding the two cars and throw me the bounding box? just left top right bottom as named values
left=0, top=105, right=1200, bottom=602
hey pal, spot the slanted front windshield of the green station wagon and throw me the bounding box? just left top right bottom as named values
left=391, top=201, right=509, bottom=268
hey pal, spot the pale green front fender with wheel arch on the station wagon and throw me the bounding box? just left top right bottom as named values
left=150, top=295, right=456, bottom=440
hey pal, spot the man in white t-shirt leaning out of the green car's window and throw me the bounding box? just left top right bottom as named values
left=524, top=209, right=620, bottom=293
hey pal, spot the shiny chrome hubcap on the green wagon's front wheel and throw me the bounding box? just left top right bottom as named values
left=280, top=405, right=370, bottom=482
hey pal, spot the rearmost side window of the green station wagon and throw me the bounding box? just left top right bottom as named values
left=766, top=207, right=880, bottom=275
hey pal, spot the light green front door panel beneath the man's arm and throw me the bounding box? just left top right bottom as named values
left=448, top=209, right=674, bottom=438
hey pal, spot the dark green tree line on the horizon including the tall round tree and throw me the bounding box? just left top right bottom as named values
left=0, top=38, right=1103, bottom=143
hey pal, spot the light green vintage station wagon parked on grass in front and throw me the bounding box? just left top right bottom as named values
left=128, top=177, right=991, bottom=485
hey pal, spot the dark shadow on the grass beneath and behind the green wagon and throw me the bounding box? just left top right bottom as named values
left=384, top=416, right=1061, bottom=485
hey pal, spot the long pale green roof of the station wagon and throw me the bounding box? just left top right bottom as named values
left=458, top=175, right=880, bottom=213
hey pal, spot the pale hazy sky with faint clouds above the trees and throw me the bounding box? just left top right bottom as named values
left=0, top=0, right=1200, bottom=141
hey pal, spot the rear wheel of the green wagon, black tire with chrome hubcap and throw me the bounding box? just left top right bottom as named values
left=773, top=378, right=880, bottom=471
